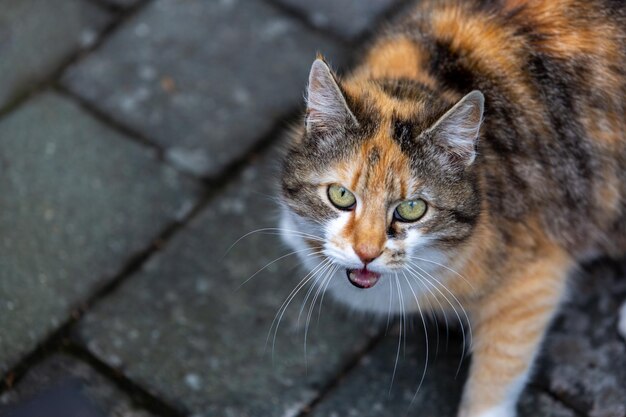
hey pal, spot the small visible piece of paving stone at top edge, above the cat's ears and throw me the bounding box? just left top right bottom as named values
left=275, top=0, right=404, bottom=40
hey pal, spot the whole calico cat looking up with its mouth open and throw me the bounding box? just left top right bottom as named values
left=281, top=0, right=626, bottom=417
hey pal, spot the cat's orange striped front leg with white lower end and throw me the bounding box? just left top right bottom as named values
left=458, top=250, right=571, bottom=417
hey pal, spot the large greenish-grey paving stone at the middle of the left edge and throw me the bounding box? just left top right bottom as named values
left=0, top=94, right=198, bottom=373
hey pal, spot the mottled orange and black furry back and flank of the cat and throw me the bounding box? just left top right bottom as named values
left=362, top=0, right=626, bottom=253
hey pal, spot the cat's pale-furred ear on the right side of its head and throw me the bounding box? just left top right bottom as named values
left=426, top=90, right=485, bottom=166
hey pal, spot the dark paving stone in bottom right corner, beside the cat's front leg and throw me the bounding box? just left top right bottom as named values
left=535, top=264, right=626, bottom=417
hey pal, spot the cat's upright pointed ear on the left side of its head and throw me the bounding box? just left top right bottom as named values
left=305, top=58, right=358, bottom=134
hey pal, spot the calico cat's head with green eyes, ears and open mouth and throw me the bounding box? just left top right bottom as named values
left=281, top=59, right=484, bottom=313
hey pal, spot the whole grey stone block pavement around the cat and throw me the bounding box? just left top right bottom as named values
left=0, top=0, right=626, bottom=417
